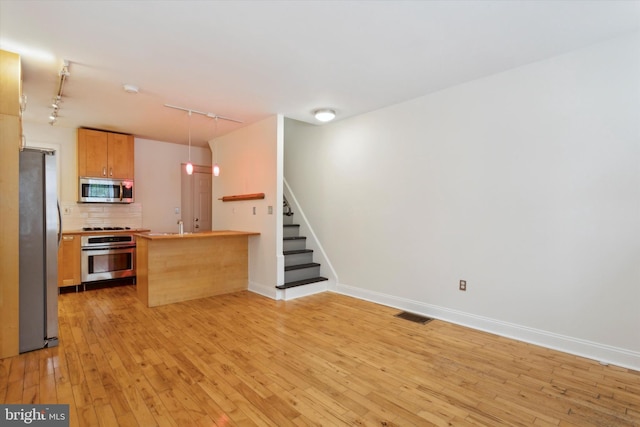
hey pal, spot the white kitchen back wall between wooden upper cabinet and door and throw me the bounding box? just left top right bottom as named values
left=135, top=138, right=211, bottom=232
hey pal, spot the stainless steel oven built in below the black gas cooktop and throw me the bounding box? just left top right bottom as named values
left=80, top=234, right=136, bottom=283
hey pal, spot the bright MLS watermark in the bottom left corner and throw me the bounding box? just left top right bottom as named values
left=0, top=405, right=69, bottom=427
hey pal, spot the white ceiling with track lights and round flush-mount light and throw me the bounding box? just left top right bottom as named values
left=0, top=0, right=640, bottom=145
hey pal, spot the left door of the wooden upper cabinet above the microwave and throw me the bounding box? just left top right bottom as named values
left=78, top=129, right=109, bottom=178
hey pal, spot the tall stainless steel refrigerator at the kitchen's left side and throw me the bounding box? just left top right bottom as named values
left=19, top=148, right=62, bottom=353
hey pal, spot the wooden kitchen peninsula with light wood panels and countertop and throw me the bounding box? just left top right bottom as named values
left=136, top=230, right=260, bottom=307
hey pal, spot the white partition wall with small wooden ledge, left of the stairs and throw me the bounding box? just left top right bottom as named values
left=209, top=116, right=284, bottom=298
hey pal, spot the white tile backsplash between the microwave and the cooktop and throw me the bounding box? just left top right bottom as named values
left=60, top=202, right=142, bottom=231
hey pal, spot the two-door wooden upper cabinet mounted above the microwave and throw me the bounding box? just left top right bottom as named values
left=78, top=128, right=134, bottom=180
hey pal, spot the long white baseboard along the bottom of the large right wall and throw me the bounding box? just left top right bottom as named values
left=330, top=284, right=640, bottom=371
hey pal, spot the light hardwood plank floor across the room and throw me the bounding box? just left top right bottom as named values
left=0, top=285, right=640, bottom=427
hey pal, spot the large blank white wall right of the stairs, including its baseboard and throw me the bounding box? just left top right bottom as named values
left=284, top=34, right=640, bottom=369
